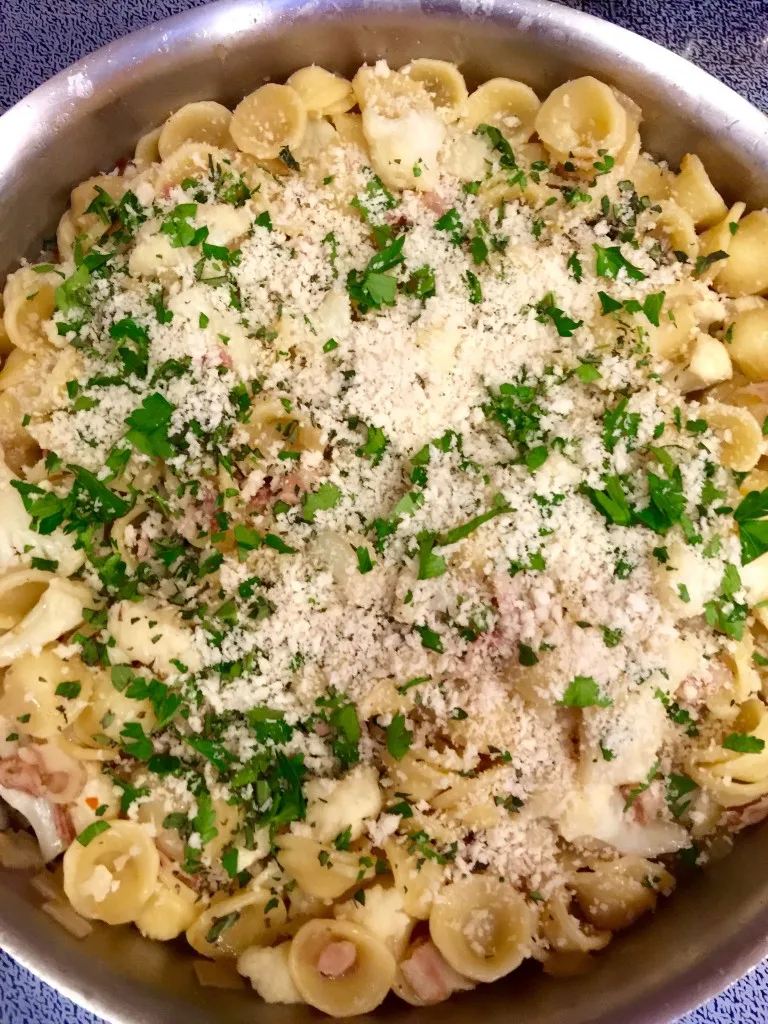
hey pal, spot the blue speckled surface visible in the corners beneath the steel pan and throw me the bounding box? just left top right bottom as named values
left=0, top=0, right=768, bottom=1024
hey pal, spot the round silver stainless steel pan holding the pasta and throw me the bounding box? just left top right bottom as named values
left=0, top=0, right=768, bottom=1024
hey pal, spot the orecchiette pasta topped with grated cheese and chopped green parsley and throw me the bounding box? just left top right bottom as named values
left=0, top=58, right=768, bottom=1017
